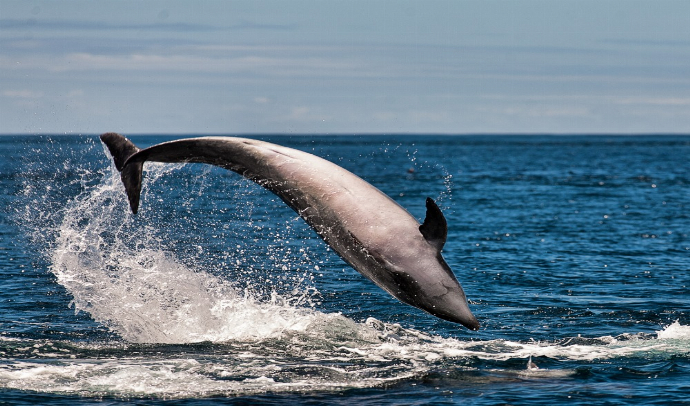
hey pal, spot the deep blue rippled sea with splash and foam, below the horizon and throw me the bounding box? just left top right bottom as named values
left=0, top=135, right=690, bottom=405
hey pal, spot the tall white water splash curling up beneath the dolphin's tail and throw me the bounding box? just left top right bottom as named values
left=25, top=143, right=331, bottom=343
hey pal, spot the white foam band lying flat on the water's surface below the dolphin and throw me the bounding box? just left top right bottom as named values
left=0, top=315, right=690, bottom=398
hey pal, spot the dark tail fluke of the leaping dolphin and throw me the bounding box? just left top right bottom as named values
left=101, top=133, right=144, bottom=214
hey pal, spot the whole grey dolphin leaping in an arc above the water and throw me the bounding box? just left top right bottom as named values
left=101, top=133, right=479, bottom=330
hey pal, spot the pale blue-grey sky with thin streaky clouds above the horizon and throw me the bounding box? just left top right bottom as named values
left=0, top=0, right=690, bottom=135
